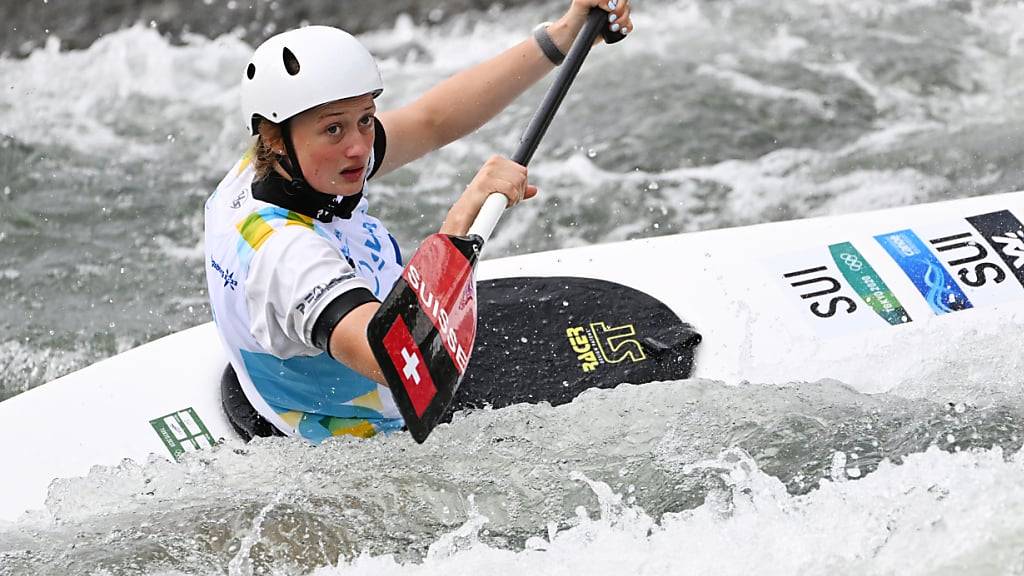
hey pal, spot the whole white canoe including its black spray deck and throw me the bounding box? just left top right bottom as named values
left=0, top=193, right=1024, bottom=521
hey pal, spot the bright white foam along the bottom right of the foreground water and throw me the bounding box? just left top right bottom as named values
left=314, top=448, right=1024, bottom=576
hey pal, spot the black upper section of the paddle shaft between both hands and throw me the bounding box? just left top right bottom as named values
left=512, top=8, right=608, bottom=166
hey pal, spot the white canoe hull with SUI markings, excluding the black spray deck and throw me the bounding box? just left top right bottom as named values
left=0, top=193, right=1024, bottom=520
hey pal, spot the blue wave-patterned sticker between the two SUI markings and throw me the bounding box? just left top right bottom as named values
left=874, top=230, right=974, bottom=315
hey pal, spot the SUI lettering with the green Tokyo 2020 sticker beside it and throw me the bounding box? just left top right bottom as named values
left=774, top=242, right=912, bottom=335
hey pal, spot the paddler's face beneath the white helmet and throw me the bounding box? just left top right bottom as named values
left=292, top=94, right=377, bottom=196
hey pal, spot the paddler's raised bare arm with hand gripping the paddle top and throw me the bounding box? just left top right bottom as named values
left=379, top=0, right=633, bottom=174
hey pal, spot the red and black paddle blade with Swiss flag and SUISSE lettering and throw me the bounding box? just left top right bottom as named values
left=367, top=234, right=483, bottom=443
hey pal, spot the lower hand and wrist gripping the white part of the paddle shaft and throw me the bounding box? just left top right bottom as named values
left=440, top=156, right=537, bottom=236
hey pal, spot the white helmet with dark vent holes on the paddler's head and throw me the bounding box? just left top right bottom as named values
left=242, top=26, right=384, bottom=135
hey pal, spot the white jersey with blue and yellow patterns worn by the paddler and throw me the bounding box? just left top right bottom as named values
left=205, top=146, right=403, bottom=442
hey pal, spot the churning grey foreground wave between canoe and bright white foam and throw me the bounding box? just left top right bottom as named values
left=0, top=380, right=1024, bottom=572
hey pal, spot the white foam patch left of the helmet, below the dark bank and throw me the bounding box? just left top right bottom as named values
left=0, top=25, right=251, bottom=162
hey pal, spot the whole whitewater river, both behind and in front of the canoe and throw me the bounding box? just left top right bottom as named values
left=0, top=0, right=1024, bottom=576
